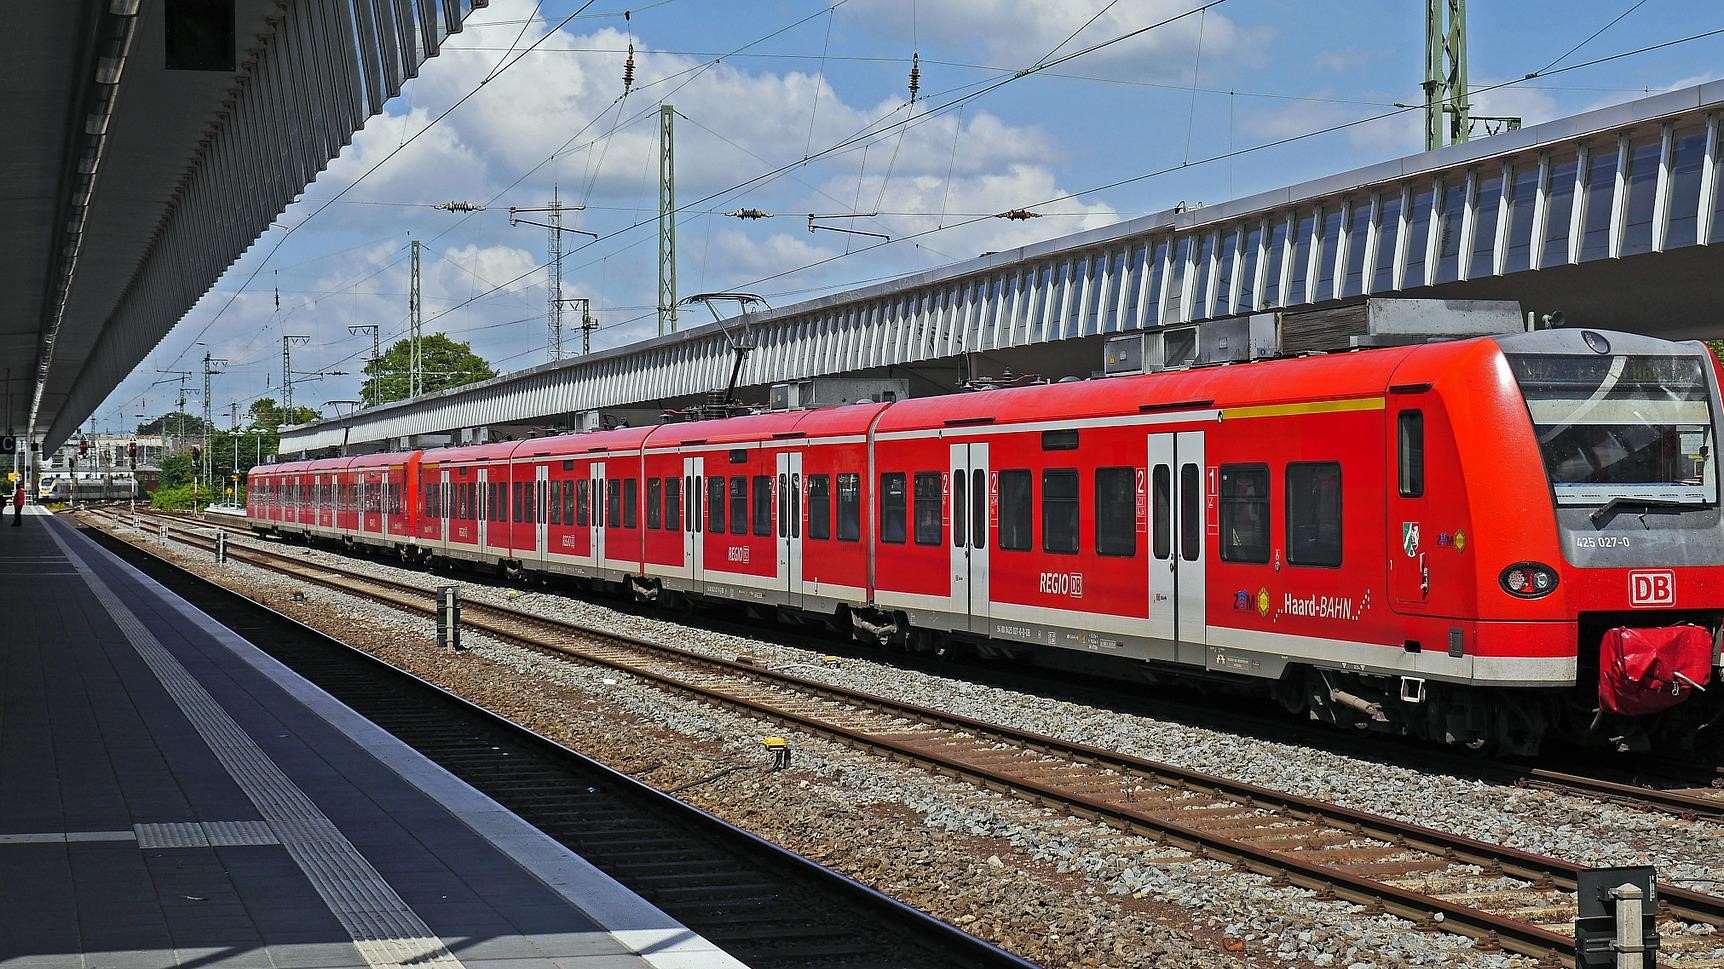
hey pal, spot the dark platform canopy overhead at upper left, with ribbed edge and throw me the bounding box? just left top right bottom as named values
left=0, top=0, right=486, bottom=450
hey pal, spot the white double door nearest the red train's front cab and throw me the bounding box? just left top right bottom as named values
left=1150, top=431, right=1209, bottom=643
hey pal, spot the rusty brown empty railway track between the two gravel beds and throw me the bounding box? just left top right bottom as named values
left=84, top=506, right=1724, bottom=966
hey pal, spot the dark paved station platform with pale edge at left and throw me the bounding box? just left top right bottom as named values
left=0, top=507, right=741, bottom=969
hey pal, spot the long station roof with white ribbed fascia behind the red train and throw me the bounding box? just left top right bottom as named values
left=281, top=81, right=1724, bottom=453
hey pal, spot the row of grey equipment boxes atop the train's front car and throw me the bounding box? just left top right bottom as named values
left=1102, top=298, right=1526, bottom=376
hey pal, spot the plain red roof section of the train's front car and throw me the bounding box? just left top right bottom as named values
left=876, top=339, right=1419, bottom=431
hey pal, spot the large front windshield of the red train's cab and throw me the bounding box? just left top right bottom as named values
left=1509, top=353, right=1717, bottom=505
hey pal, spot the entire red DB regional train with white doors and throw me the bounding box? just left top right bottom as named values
left=248, top=329, right=1724, bottom=752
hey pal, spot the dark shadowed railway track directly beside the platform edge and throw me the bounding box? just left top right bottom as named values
left=81, top=506, right=1031, bottom=969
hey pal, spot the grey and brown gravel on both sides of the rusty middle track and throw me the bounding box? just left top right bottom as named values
left=104, top=510, right=1724, bottom=969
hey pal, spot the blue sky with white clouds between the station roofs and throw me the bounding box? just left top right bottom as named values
left=86, top=0, right=1724, bottom=429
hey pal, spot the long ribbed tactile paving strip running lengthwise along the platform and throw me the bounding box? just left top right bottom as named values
left=48, top=529, right=462, bottom=969
